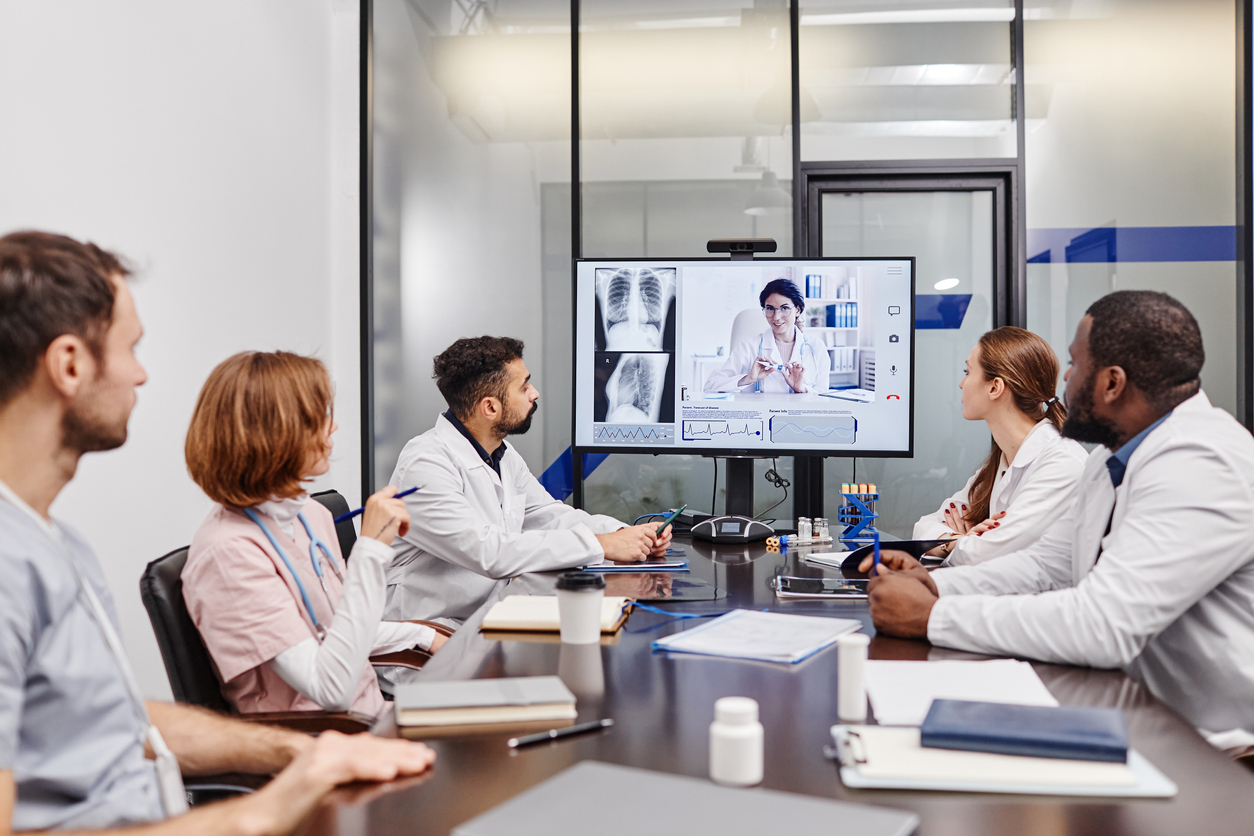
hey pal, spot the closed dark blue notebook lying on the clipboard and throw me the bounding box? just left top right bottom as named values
left=919, top=699, right=1127, bottom=763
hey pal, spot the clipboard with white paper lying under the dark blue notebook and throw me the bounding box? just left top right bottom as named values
left=828, top=726, right=1178, bottom=798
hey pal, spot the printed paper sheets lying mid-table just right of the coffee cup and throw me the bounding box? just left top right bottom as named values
left=653, top=609, right=861, bottom=664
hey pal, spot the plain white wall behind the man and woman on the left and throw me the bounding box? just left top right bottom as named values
left=0, top=0, right=361, bottom=697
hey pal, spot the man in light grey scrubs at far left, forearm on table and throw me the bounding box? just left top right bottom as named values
left=0, top=232, right=435, bottom=836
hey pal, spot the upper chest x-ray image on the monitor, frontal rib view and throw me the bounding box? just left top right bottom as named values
left=594, top=267, right=675, bottom=351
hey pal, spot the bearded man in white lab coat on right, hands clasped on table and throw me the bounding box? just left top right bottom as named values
left=865, top=291, right=1254, bottom=748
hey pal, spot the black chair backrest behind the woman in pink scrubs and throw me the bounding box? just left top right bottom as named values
left=139, top=546, right=234, bottom=713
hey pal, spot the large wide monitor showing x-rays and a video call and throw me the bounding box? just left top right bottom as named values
left=574, top=257, right=914, bottom=456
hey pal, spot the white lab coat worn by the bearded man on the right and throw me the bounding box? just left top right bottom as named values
left=928, top=392, right=1254, bottom=732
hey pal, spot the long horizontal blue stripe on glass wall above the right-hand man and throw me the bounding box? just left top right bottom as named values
left=1027, top=227, right=1236, bottom=264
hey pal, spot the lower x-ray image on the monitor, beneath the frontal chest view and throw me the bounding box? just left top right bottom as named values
left=592, top=351, right=675, bottom=424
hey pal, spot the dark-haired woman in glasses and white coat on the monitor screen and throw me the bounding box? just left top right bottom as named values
left=705, top=278, right=830, bottom=395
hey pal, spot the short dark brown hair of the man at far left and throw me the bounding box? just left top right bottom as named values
left=0, top=232, right=130, bottom=405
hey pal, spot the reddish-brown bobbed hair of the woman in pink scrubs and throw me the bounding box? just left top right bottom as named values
left=183, top=351, right=334, bottom=508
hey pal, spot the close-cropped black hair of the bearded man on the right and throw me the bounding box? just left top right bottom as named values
left=1086, top=291, right=1206, bottom=410
